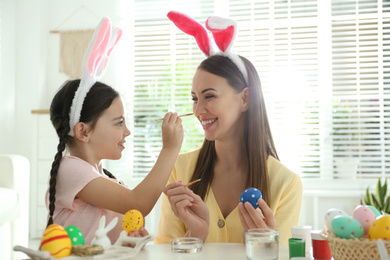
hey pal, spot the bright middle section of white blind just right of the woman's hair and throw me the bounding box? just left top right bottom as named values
left=229, top=0, right=320, bottom=177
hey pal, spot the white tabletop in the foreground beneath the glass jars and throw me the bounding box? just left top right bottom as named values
left=136, top=243, right=288, bottom=260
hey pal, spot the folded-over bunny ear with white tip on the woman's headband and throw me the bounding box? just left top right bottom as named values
left=206, top=16, right=237, bottom=52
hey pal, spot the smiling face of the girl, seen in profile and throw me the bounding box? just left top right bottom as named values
left=88, top=97, right=130, bottom=160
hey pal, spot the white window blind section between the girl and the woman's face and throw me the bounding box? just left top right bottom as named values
left=128, top=1, right=214, bottom=177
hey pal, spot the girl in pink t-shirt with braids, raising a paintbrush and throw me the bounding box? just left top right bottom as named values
left=46, top=80, right=183, bottom=244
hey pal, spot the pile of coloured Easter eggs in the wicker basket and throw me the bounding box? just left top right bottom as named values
left=325, top=205, right=390, bottom=240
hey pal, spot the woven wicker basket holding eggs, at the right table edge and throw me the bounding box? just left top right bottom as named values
left=320, top=230, right=390, bottom=260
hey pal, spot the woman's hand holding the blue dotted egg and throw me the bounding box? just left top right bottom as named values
left=238, top=199, right=276, bottom=240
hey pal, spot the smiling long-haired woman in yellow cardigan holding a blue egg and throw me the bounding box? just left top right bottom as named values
left=155, top=55, right=302, bottom=244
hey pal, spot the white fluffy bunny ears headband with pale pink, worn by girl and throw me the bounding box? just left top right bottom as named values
left=68, top=17, right=122, bottom=136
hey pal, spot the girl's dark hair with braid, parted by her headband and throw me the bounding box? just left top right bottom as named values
left=47, top=80, right=119, bottom=226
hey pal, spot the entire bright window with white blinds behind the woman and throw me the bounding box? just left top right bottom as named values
left=110, top=0, right=390, bottom=183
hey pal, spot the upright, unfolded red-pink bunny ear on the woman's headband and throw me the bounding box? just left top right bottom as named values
left=167, top=11, right=211, bottom=56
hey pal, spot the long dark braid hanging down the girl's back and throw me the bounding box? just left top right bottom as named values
left=47, top=123, right=69, bottom=226
